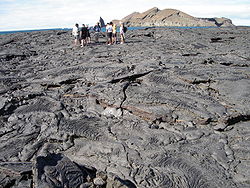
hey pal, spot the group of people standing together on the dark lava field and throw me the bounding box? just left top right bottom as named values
left=72, top=22, right=127, bottom=47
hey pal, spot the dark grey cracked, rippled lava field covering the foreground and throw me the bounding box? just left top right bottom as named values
left=0, top=27, right=250, bottom=188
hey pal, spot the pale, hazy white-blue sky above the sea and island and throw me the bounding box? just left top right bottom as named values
left=0, top=0, right=250, bottom=31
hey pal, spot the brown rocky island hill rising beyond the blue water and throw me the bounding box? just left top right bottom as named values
left=113, top=7, right=234, bottom=27
